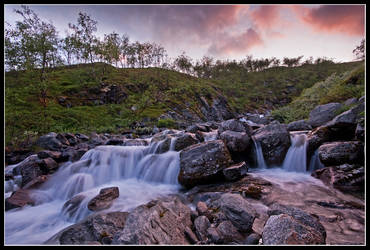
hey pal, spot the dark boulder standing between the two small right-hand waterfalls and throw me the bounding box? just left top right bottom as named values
left=254, top=123, right=291, bottom=166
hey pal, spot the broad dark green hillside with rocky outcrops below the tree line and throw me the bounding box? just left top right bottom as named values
left=5, top=62, right=361, bottom=145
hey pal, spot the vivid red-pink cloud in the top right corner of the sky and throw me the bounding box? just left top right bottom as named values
left=292, top=5, right=365, bottom=36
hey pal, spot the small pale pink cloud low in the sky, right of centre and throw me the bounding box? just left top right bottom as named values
left=208, top=28, right=263, bottom=56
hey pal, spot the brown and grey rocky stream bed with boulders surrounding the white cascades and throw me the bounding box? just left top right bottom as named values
left=5, top=98, right=365, bottom=245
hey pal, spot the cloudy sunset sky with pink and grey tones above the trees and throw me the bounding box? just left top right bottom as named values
left=4, top=4, right=365, bottom=62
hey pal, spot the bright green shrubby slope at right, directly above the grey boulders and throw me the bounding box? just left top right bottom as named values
left=272, top=63, right=365, bottom=123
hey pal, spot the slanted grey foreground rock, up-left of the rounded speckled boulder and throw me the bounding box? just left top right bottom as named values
left=210, top=193, right=256, bottom=232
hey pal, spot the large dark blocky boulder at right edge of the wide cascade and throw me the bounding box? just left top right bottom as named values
left=178, top=140, right=231, bottom=188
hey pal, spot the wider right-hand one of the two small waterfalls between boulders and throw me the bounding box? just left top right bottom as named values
left=282, top=131, right=307, bottom=172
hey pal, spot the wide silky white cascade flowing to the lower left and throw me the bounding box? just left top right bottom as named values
left=5, top=137, right=180, bottom=244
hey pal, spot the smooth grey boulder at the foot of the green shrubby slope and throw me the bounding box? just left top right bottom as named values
left=308, top=102, right=343, bottom=128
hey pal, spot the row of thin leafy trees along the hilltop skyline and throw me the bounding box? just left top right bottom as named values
left=5, top=5, right=364, bottom=80
